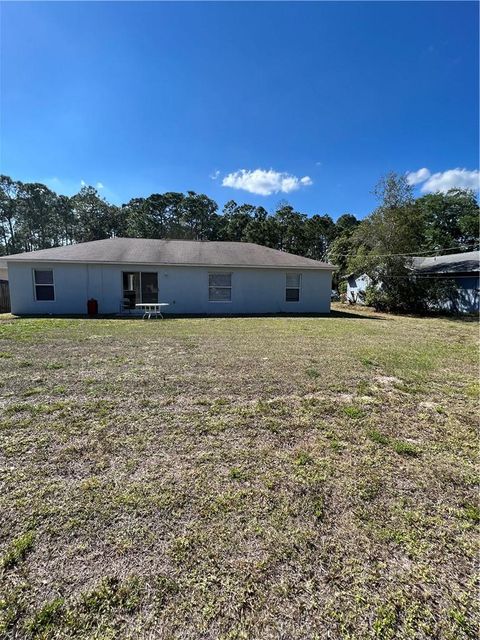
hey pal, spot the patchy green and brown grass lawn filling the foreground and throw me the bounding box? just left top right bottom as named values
left=0, top=307, right=480, bottom=640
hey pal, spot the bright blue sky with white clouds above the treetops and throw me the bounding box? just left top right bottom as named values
left=0, top=2, right=479, bottom=218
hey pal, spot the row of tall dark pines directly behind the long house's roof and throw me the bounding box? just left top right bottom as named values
left=0, top=176, right=359, bottom=260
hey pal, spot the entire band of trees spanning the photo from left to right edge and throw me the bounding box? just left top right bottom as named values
left=0, top=173, right=479, bottom=309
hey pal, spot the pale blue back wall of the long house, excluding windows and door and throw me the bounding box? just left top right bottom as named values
left=9, top=262, right=332, bottom=315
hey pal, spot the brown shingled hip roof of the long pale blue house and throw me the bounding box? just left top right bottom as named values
left=7, top=238, right=336, bottom=270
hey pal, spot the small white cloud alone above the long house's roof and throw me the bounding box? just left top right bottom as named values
left=222, top=169, right=313, bottom=196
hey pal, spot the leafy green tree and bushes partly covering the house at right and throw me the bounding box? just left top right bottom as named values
left=347, top=174, right=478, bottom=312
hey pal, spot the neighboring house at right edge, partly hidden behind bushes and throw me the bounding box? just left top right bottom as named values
left=347, top=251, right=480, bottom=313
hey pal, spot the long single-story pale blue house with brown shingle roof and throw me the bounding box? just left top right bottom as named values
left=7, top=238, right=335, bottom=315
